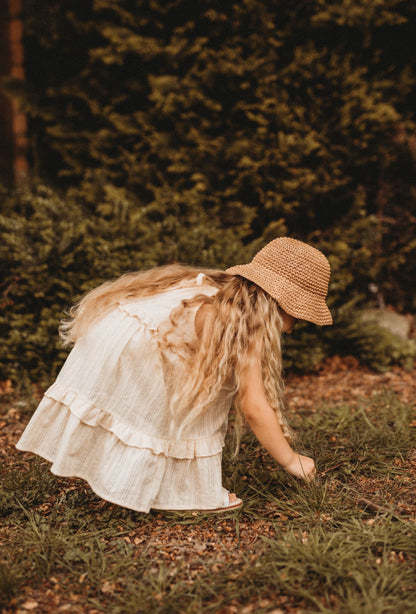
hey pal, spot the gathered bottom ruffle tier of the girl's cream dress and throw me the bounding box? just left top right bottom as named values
left=16, top=398, right=227, bottom=512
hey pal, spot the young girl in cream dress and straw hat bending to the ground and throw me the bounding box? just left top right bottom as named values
left=17, top=237, right=332, bottom=512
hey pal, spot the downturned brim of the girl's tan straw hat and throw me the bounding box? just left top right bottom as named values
left=225, top=263, right=332, bottom=326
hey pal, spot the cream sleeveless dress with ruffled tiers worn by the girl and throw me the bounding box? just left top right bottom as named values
left=17, top=274, right=231, bottom=512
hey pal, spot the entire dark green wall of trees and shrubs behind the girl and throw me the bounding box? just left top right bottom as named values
left=0, top=0, right=416, bottom=379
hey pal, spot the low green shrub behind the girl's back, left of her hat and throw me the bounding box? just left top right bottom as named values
left=0, top=186, right=245, bottom=380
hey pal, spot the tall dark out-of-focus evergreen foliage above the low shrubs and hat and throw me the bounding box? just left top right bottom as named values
left=13, top=0, right=416, bottom=311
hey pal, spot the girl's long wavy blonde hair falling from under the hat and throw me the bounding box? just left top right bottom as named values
left=60, top=264, right=291, bottom=440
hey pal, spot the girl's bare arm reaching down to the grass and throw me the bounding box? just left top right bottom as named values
left=240, top=359, right=315, bottom=479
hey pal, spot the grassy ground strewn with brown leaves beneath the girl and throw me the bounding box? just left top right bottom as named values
left=0, top=359, right=416, bottom=614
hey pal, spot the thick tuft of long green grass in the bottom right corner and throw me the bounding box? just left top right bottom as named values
left=251, top=519, right=416, bottom=614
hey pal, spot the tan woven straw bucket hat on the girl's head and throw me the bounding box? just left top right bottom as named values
left=226, top=237, right=332, bottom=325
